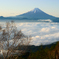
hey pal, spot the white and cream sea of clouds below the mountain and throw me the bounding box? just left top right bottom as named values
left=0, top=22, right=59, bottom=46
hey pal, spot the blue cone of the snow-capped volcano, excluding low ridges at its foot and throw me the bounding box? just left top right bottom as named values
left=16, top=8, right=56, bottom=19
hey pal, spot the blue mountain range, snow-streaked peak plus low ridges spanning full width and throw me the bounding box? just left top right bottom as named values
left=0, top=8, right=59, bottom=21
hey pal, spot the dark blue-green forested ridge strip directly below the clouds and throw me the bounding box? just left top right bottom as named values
left=18, top=41, right=59, bottom=52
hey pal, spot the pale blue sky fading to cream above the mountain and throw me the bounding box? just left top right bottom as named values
left=0, top=0, right=59, bottom=17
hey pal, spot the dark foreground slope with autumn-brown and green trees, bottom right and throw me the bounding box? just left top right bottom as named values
left=4, top=41, right=59, bottom=59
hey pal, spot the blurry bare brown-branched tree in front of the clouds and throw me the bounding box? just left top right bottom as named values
left=0, top=21, right=31, bottom=59
